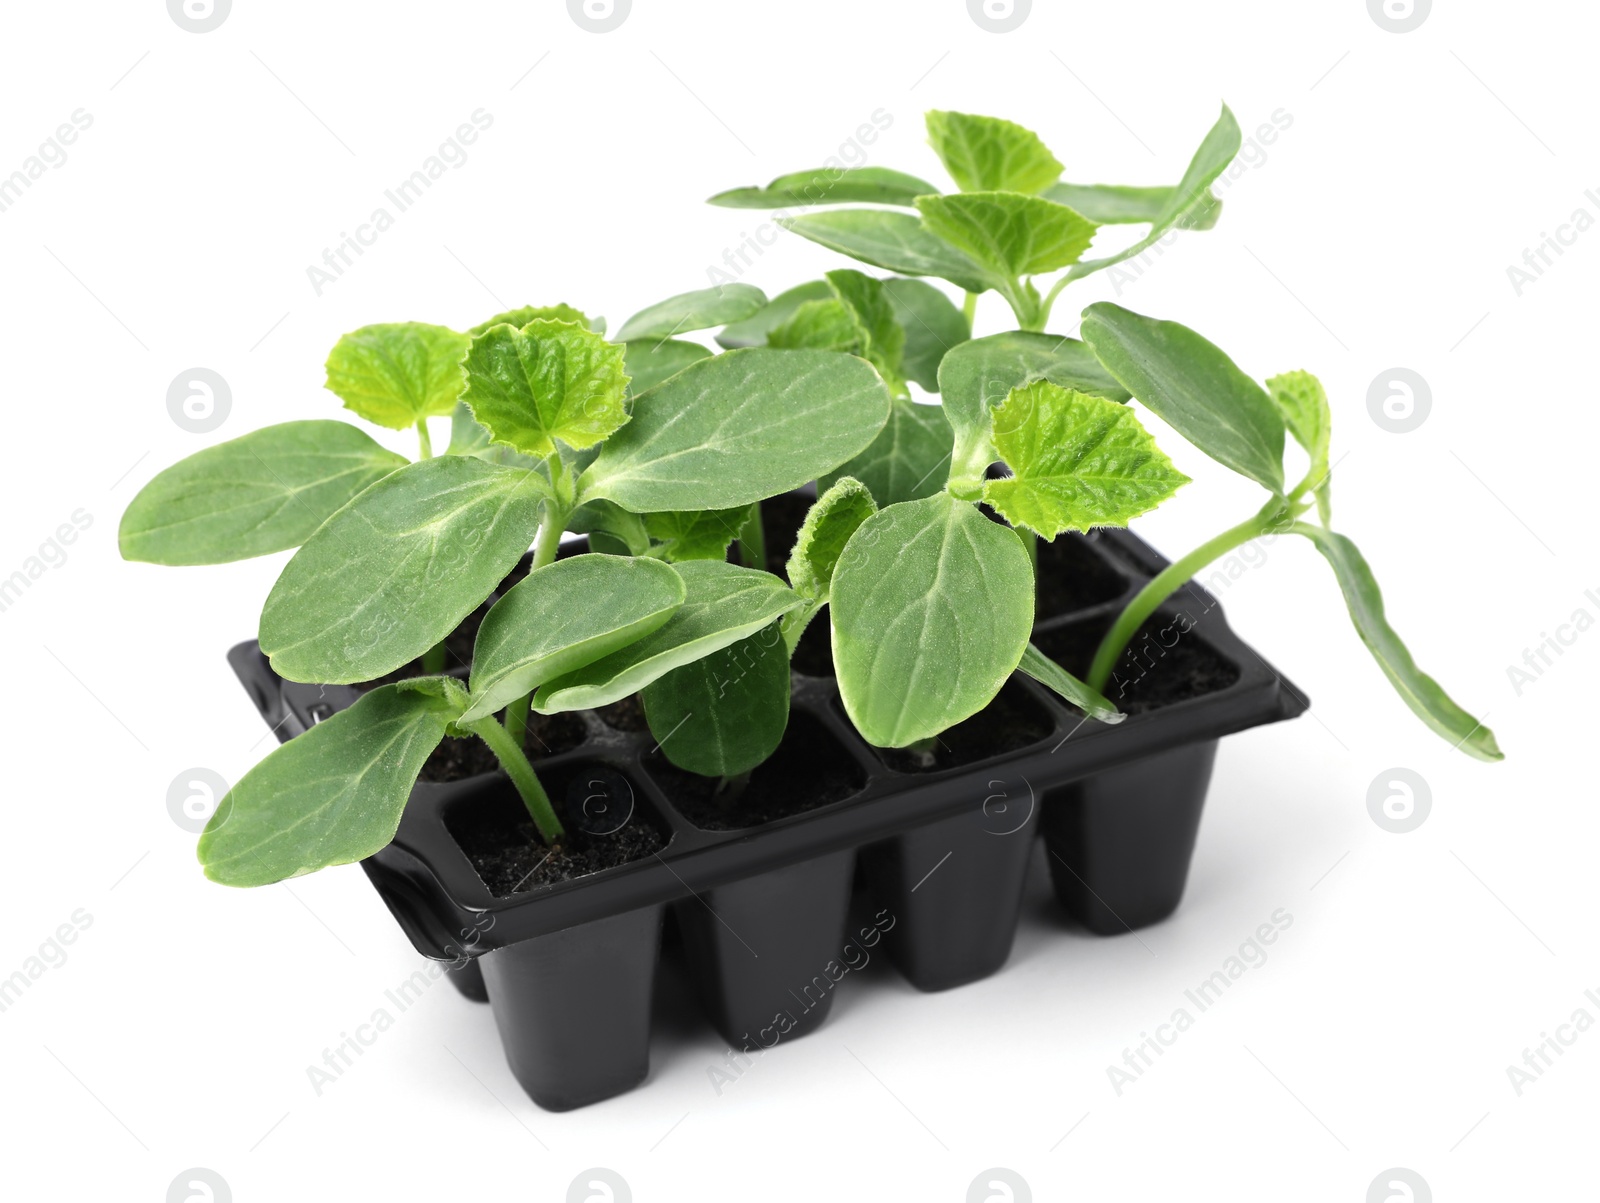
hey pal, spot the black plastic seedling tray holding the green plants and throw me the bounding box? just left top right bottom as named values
left=229, top=531, right=1307, bottom=1109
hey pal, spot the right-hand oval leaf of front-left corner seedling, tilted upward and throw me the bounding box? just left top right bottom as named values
left=461, top=555, right=686, bottom=721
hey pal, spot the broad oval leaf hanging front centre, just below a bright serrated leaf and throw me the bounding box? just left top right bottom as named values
left=830, top=493, right=1034, bottom=747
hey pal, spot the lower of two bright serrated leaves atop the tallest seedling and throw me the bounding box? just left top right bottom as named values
left=917, top=192, right=1098, bottom=280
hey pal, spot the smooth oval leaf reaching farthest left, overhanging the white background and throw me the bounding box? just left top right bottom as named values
left=117, top=421, right=408, bottom=565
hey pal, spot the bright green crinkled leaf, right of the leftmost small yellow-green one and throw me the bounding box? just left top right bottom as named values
left=461, top=318, right=627, bottom=458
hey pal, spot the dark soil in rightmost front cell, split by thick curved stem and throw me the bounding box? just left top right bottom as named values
left=1034, top=614, right=1238, bottom=713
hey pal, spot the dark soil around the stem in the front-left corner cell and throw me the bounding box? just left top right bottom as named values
left=445, top=765, right=667, bottom=897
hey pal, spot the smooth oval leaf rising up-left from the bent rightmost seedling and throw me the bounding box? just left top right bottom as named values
left=1083, top=301, right=1283, bottom=493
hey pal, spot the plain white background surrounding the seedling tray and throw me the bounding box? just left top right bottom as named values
left=0, top=0, right=1600, bottom=1203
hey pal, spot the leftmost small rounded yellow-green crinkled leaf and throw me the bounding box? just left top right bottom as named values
left=326, top=322, right=469, bottom=430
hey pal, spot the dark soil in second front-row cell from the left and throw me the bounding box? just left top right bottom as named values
left=645, top=710, right=867, bottom=832
